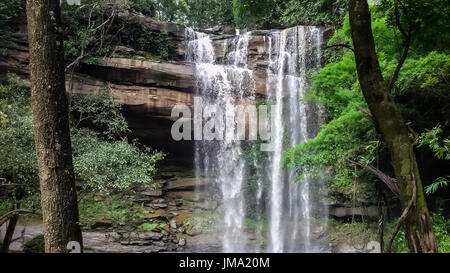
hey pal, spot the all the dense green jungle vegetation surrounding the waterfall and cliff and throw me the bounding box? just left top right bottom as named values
left=0, top=0, right=450, bottom=252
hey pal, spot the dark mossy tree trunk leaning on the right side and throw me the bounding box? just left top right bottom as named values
left=349, top=0, right=437, bottom=252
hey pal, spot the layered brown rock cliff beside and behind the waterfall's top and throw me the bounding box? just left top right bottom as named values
left=0, top=15, right=328, bottom=163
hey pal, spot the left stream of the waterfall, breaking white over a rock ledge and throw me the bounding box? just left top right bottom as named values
left=186, top=27, right=255, bottom=252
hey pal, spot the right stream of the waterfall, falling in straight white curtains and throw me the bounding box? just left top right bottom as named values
left=267, top=26, right=322, bottom=252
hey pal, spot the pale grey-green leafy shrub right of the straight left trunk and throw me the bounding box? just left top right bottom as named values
left=72, top=129, right=164, bottom=193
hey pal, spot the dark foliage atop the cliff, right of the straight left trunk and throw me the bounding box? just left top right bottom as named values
left=62, top=0, right=177, bottom=63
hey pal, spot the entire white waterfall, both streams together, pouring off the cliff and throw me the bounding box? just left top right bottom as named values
left=186, top=26, right=326, bottom=252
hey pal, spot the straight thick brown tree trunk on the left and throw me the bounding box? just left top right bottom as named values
left=27, top=0, right=82, bottom=253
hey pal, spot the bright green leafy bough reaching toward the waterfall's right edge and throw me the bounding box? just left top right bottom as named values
left=283, top=109, right=376, bottom=188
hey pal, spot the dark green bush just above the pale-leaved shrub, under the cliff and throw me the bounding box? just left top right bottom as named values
left=71, top=88, right=130, bottom=140
